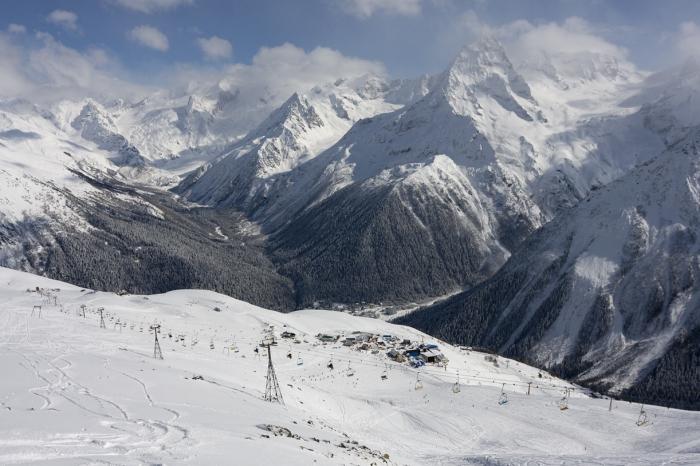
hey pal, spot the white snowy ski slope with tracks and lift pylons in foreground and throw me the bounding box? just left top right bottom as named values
left=0, top=269, right=700, bottom=465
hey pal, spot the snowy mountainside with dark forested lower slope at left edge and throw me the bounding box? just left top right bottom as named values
left=0, top=101, right=294, bottom=310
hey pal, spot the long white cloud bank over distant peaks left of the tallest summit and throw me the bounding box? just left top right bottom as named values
left=0, top=32, right=386, bottom=110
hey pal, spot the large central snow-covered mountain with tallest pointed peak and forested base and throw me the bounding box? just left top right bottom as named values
left=178, top=39, right=665, bottom=304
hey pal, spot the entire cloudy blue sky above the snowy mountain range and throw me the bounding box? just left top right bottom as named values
left=0, top=0, right=700, bottom=102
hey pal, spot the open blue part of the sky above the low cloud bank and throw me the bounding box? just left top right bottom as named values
left=3, top=0, right=700, bottom=76
